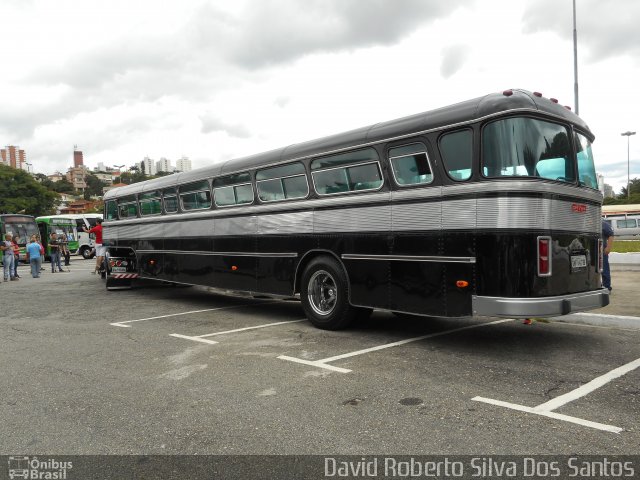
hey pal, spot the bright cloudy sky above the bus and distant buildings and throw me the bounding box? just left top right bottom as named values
left=0, top=0, right=640, bottom=191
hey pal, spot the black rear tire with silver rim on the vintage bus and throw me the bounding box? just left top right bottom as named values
left=300, top=256, right=357, bottom=330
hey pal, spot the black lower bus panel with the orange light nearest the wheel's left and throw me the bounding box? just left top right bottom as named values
left=212, top=236, right=258, bottom=292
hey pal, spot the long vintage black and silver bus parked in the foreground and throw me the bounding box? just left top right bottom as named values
left=103, top=90, right=609, bottom=329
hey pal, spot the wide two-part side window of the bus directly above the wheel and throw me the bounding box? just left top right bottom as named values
left=311, top=148, right=383, bottom=195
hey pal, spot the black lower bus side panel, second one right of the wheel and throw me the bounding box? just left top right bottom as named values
left=389, top=233, right=447, bottom=316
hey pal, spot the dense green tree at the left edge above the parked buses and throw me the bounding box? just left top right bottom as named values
left=0, top=165, right=58, bottom=217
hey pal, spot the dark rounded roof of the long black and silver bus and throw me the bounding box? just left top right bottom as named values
left=104, top=89, right=594, bottom=200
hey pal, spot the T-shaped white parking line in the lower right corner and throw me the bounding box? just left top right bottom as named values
left=471, top=358, right=640, bottom=433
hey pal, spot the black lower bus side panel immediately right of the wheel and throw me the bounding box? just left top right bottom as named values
left=343, top=235, right=393, bottom=309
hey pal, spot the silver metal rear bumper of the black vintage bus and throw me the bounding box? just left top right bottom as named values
left=472, top=288, right=609, bottom=318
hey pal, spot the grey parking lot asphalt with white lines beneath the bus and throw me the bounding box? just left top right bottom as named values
left=0, top=258, right=640, bottom=455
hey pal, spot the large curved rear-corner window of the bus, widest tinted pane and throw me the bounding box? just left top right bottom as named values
left=482, top=118, right=576, bottom=183
